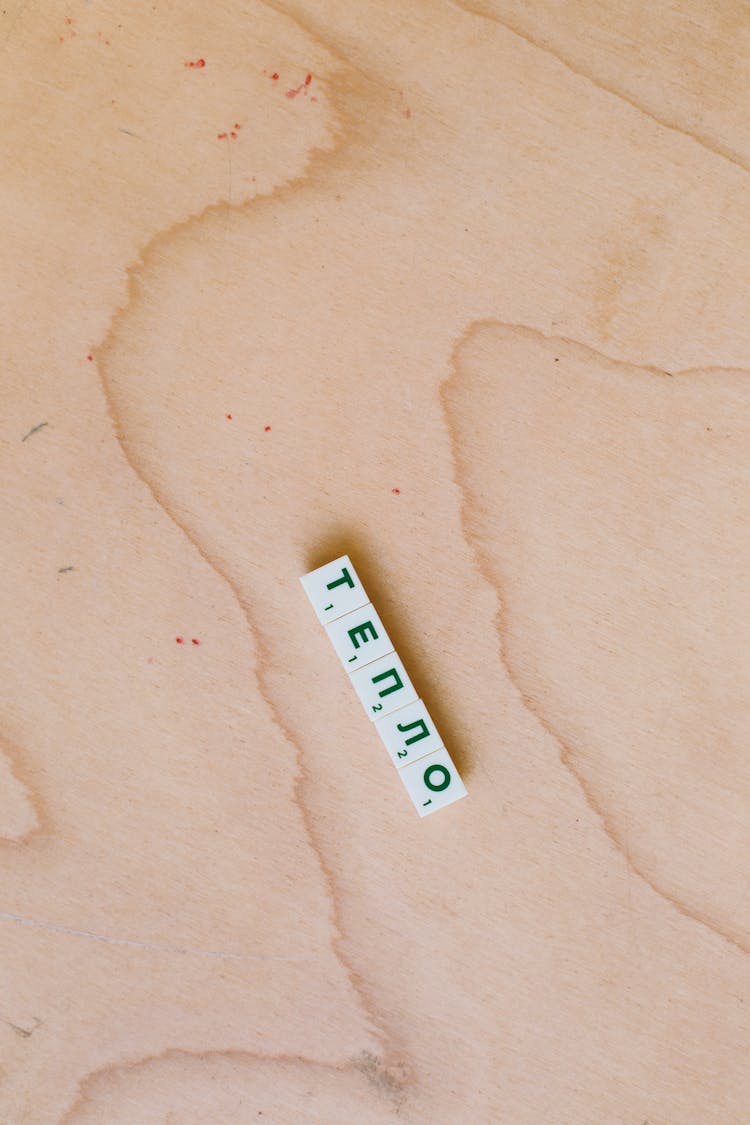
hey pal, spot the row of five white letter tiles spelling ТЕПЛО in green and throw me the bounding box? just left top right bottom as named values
left=299, top=555, right=467, bottom=817
